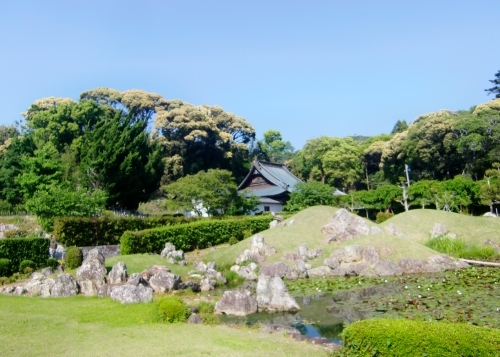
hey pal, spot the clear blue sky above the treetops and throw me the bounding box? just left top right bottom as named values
left=0, top=0, right=500, bottom=149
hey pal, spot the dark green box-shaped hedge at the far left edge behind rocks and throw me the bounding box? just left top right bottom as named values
left=0, top=238, right=50, bottom=268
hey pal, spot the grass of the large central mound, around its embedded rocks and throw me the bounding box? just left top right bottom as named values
left=203, top=206, right=438, bottom=267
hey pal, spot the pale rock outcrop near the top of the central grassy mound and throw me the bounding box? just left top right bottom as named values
left=321, top=208, right=384, bottom=243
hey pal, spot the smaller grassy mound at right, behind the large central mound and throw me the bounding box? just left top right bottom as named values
left=380, top=209, right=500, bottom=245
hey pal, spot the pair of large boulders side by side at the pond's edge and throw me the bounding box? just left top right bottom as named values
left=215, top=275, right=300, bottom=316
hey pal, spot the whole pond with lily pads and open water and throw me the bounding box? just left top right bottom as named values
left=220, top=267, right=500, bottom=343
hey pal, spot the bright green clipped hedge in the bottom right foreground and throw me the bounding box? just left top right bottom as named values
left=335, top=318, right=500, bottom=357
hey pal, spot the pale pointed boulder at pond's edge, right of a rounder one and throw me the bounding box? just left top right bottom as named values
left=257, top=275, right=300, bottom=312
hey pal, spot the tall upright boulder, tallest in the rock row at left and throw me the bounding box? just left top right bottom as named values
left=76, top=248, right=106, bottom=296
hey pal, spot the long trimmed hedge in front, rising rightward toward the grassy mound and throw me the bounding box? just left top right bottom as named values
left=120, top=216, right=273, bottom=255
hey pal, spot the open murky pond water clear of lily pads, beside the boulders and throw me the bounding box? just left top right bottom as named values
left=220, top=286, right=398, bottom=343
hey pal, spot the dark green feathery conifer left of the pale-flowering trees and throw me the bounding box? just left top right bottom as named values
left=79, top=111, right=163, bottom=210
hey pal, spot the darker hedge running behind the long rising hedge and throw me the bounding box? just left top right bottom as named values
left=54, top=217, right=197, bottom=247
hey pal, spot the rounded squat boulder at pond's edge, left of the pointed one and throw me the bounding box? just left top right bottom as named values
left=215, top=289, right=257, bottom=316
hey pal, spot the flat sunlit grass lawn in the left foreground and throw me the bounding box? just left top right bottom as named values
left=0, top=295, right=327, bottom=357
